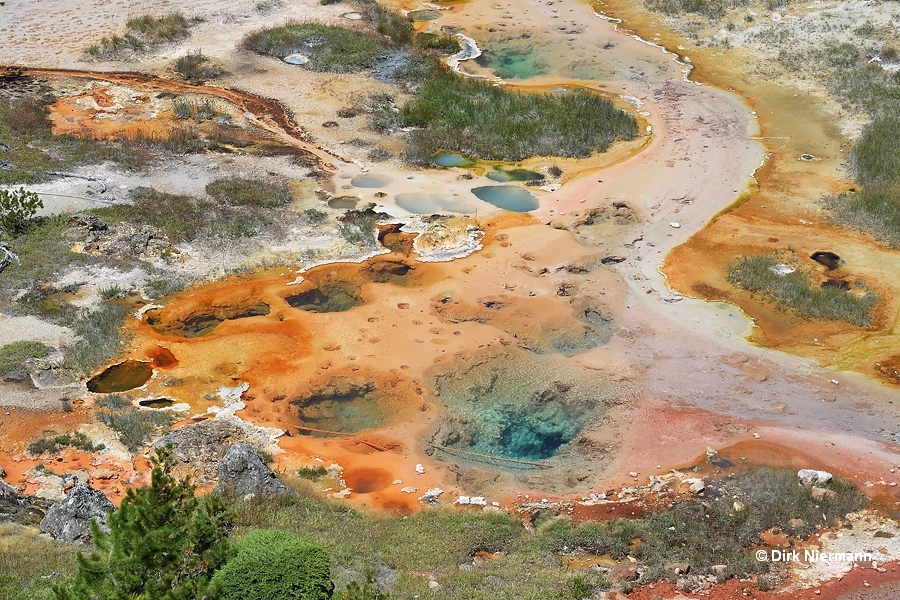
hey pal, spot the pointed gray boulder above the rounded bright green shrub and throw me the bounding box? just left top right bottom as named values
left=216, top=444, right=297, bottom=500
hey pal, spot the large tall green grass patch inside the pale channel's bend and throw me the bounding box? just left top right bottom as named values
left=400, top=70, right=638, bottom=163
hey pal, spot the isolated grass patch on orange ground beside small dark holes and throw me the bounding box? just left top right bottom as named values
left=726, top=253, right=878, bottom=327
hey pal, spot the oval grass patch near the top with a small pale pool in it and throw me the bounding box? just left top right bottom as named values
left=243, top=21, right=392, bottom=73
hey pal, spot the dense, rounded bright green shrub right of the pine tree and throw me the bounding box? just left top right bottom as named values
left=214, top=529, right=334, bottom=600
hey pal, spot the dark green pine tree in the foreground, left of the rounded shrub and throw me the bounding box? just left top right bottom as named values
left=54, top=448, right=230, bottom=600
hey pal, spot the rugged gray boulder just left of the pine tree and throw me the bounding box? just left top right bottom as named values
left=40, top=483, right=113, bottom=544
